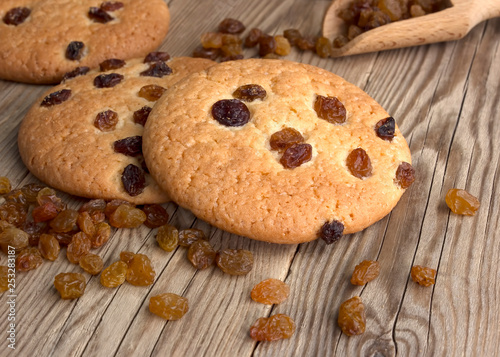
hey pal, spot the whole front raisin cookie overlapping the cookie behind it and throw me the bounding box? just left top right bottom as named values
left=143, top=59, right=413, bottom=244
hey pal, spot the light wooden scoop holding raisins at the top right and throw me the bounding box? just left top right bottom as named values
left=323, top=0, right=500, bottom=57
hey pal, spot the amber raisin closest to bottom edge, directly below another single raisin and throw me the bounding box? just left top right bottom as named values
left=250, top=314, right=295, bottom=341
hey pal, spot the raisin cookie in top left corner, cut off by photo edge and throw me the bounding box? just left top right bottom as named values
left=0, top=0, right=170, bottom=83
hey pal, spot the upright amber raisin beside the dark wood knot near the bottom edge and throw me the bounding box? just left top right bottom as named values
left=337, top=296, right=366, bottom=336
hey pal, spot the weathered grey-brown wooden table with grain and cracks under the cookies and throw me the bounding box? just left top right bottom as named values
left=0, top=0, right=500, bottom=356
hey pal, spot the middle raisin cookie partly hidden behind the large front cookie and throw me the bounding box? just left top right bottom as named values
left=18, top=52, right=214, bottom=204
